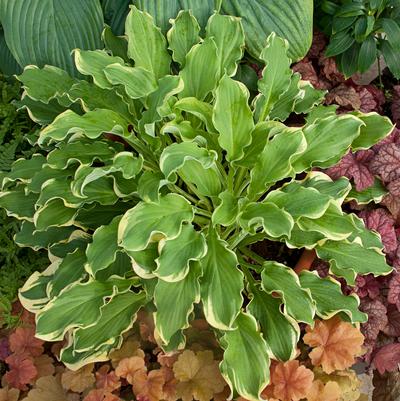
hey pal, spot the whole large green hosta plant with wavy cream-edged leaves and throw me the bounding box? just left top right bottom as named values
left=0, top=8, right=392, bottom=400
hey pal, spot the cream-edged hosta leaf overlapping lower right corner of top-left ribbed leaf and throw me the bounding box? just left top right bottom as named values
left=75, top=49, right=124, bottom=89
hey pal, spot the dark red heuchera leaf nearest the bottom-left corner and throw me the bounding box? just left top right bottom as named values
left=4, top=355, right=37, bottom=390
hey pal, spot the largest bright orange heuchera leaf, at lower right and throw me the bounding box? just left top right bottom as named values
left=303, top=316, right=364, bottom=373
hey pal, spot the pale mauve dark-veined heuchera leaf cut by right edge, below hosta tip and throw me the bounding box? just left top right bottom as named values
left=370, top=143, right=400, bottom=182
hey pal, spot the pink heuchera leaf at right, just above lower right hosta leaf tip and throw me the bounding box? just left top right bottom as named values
left=360, top=208, right=398, bottom=253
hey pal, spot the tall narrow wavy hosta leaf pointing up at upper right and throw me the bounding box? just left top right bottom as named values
left=255, top=33, right=292, bottom=121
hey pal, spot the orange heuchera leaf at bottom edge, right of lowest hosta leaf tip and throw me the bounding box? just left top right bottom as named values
left=271, top=360, right=314, bottom=401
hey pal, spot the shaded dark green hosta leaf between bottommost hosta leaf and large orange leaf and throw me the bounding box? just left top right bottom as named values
left=247, top=287, right=300, bottom=361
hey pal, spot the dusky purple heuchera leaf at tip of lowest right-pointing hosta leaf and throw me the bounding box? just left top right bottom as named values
left=360, top=298, right=388, bottom=340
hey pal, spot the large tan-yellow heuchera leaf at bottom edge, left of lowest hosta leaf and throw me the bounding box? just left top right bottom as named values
left=173, top=350, right=226, bottom=401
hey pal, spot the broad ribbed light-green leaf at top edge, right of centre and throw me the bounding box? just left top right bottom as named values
left=222, top=0, right=313, bottom=60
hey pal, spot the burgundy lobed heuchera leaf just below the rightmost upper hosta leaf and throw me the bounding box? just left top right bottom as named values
left=326, top=150, right=374, bottom=191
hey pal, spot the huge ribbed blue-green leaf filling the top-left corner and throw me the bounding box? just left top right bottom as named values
left=0, top=0, right=104, bottom=75
